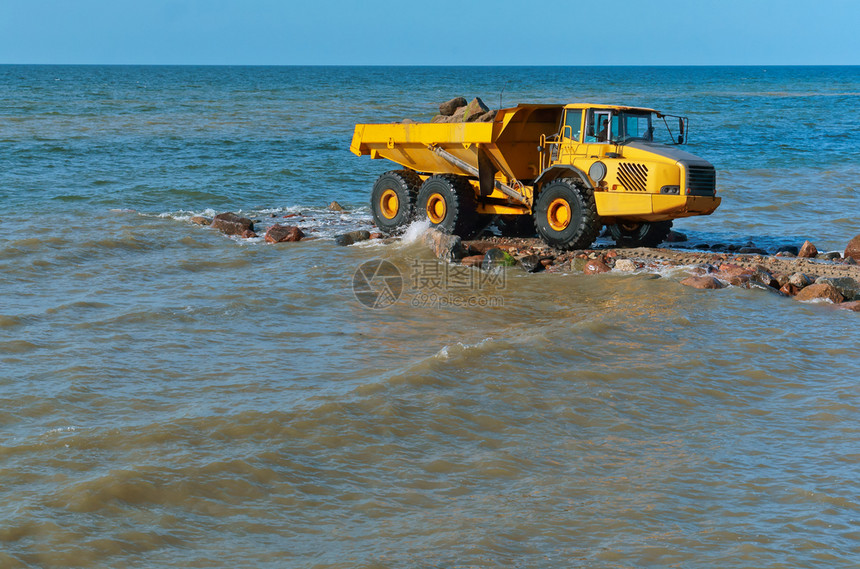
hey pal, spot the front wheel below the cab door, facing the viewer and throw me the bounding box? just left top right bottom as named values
left=534, top=178, right=601, bottom=249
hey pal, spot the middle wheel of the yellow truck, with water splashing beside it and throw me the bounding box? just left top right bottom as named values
left=416, top=174, right=478, bottom=235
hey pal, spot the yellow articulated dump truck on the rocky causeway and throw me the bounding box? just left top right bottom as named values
left=350, top=104, right=720, bottom=249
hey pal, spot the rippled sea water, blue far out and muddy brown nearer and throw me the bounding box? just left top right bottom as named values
left=0, top=66, right=860, bottom=568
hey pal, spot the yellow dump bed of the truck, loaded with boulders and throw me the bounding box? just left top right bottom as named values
left=350, top=105, right=564, bottom=180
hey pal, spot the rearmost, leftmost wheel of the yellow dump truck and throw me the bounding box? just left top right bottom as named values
left=370, top=170, right=421, bottom=234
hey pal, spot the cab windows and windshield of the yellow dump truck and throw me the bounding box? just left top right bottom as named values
left=585, top=109, right=687, bottom=144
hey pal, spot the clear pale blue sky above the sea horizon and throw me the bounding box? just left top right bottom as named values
left=0, top=0, right=860, bottom=65
